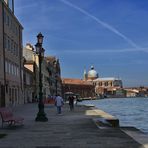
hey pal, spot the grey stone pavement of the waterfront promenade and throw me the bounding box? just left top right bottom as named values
left=0, top=104, right=146, bottom=148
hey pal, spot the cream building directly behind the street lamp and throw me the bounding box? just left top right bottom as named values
left=23, top=43, right=51, bottom=99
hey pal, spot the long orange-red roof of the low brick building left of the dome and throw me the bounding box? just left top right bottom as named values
left=62, top=78, right=92, bottom=85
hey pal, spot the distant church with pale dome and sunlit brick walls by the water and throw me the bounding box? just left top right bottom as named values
left=83, top=66, right=125, bottom=97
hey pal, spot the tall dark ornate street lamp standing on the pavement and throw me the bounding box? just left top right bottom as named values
left=35, top=33, right=48, bottom=122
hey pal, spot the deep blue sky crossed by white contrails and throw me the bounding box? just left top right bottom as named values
left=15, top=0, right=148, bottom=87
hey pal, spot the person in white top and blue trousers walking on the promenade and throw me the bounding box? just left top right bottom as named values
left=55, top=94, right=64, bottom=114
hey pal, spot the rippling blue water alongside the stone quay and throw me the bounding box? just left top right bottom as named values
left=80, top=98, right=148, bottom=134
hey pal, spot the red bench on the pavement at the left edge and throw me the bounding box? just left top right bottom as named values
left=0, top=108, right=24, bottom=128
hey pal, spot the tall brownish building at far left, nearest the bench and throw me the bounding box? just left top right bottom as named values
left=0, top=0, right=23, bottom=106
